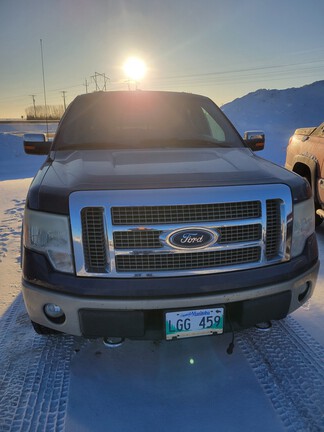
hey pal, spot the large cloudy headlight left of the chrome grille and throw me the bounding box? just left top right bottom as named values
left=24, top=209, right=74, bottom=273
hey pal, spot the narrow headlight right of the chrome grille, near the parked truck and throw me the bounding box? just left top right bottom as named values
left=291, top=198, right=315, bottom=258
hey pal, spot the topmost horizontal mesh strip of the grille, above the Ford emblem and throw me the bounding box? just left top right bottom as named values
left=111, top=201, right=261, bottom=225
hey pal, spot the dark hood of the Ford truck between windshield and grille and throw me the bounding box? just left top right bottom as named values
left=28, top=148, right=303, bottom=214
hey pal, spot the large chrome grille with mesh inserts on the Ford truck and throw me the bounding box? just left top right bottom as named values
left=70, top=184, right=292, bottom=278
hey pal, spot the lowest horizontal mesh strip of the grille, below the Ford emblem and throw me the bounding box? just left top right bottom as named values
left=116, top=247, right=261, bottom=272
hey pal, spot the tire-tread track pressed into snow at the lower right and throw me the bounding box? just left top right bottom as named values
left=237, top=317, right=324, bottom=432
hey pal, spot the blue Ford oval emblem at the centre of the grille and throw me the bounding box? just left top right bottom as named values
left=167, top=228, right=218, bottom=249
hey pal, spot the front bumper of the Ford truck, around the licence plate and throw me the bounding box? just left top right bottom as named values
left=22, top=261, right=319, bottom=339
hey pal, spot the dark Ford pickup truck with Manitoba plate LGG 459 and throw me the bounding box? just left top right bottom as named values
left=22, top=91, right=319, bottom=339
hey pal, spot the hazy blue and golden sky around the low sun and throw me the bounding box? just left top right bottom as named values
left=0, top=0, right=324, bottom=118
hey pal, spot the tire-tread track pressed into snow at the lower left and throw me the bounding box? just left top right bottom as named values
left=0, top=295, right=82, bottom=432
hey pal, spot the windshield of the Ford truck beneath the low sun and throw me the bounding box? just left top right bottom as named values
left=54, top=91, right=243, bottom=150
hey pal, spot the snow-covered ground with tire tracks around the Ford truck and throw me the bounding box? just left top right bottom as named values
left=0, top=125, right=324, bottom=432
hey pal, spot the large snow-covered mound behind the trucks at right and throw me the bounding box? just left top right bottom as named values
left=222, top=81, right=324, bottom=165
